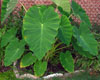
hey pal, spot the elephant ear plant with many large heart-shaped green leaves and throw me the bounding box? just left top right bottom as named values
left=1, top=0, right=98, bottom=76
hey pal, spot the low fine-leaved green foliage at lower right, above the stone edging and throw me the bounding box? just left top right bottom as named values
left=76, top=55, right=100, bottom=72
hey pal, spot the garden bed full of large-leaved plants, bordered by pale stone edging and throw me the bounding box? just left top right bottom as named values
left=0, top=0, right=100, bottom=79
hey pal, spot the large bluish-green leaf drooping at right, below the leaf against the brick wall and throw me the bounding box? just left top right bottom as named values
left=74, top=23, right=98, bottom=56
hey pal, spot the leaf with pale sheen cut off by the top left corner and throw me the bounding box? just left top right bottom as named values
left=1, top=0, right=18, bottom=23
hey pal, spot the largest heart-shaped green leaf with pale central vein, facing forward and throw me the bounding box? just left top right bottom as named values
left=23, top=6, right=60, bottom=60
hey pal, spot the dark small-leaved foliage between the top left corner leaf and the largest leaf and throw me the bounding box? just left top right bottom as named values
left=6, top=7, right=25, bottom=30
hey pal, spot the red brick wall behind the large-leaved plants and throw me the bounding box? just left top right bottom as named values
left=1, top=0, right=100, bottom=25
